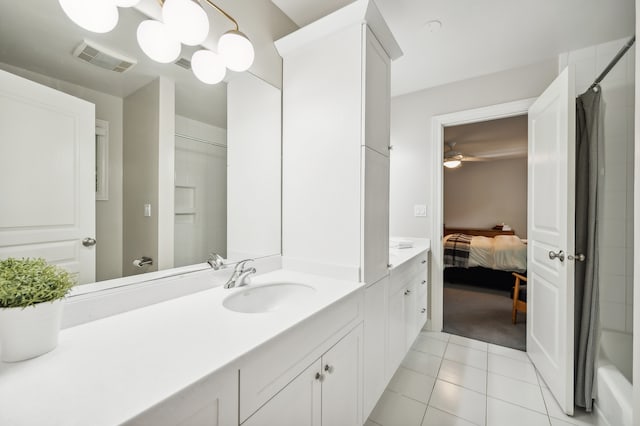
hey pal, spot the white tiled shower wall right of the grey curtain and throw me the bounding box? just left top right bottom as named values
left=559, top=38, right=635, bottom=333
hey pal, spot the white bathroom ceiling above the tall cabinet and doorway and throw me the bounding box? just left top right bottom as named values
left=271, top=0, right=635, bottom=96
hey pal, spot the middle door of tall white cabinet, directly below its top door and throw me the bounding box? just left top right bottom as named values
left=362, top=147, right=389, bottom=284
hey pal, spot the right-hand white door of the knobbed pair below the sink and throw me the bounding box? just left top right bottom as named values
left=322, top=326, right=363, bottom=426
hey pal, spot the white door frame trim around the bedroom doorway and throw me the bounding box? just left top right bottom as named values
left=431, top=98, right=536, bottom=331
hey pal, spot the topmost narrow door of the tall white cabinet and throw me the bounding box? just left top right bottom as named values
left=364, top=27, right=391, bottom=157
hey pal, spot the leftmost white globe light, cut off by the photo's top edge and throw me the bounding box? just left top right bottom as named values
left=59, top=0, right=118, bottom=33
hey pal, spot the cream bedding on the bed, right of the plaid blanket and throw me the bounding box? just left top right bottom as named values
left=444, top=235, right=527, bottom=272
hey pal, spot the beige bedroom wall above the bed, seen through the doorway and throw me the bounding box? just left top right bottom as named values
left=444, top=158, right=527, bottom=238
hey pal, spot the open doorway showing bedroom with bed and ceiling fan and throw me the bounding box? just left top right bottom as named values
left=442, top=115, right=527, bottom=350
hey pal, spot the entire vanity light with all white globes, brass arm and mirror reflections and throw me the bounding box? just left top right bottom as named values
left=58, top=0, right=255, bottom=84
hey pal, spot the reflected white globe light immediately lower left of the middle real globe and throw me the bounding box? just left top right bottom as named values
left=137, top=19, right=180, bottom=64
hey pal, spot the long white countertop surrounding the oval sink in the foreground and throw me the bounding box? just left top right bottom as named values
left=0, top=270, right=363, bottom=426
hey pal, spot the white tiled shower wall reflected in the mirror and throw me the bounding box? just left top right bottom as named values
left=174, top=115, right=227, bottom=267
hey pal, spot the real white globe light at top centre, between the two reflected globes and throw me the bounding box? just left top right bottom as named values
left=162, top=0, right=209, bottom=46
